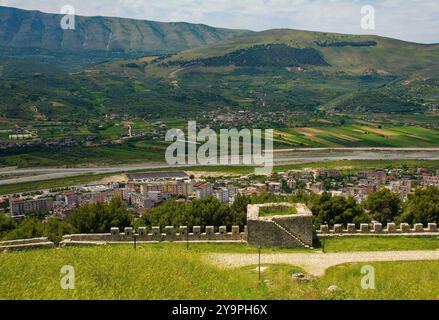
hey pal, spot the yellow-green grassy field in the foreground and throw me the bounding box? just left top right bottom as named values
left=0, top=240, right=439, bottom=300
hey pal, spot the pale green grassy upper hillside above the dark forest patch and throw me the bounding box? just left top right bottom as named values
left=172, top=29, right=439, bottom=75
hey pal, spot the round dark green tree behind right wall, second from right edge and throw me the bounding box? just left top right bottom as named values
left=363, top=188, right=402, bottom=224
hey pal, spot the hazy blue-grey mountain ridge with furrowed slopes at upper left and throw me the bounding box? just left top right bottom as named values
left=0, top=6, right=251, bottom=54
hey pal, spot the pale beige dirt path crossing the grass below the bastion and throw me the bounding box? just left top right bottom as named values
left=208, top=250, right=439, bottom=277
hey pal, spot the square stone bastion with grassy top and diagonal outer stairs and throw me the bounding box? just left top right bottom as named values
left=247, top=203, right=314, bottom=248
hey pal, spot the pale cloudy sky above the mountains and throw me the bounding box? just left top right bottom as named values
left=0, top=0, right=439, bottom=43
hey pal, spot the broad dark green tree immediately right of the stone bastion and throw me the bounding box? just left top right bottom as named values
left=311, top=192, right=370, bottom=228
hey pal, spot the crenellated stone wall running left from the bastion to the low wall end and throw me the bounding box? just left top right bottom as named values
left=63, top=226, right=247, bottom=244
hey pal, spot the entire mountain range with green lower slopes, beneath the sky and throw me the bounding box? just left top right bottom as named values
left=0, top=7, right=439, bottom=121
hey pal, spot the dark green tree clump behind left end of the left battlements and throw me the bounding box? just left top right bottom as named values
left=67, top=198, right=132, bottom=233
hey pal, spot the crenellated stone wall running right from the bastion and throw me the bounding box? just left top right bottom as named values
left=316, top=223, right=439, bottom=237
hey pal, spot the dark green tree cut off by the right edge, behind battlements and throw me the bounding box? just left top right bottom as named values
left=398, top=187, right=439, bottom=225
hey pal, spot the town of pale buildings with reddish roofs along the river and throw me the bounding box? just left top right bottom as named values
left=0, top=168, right=439, bottom=220
